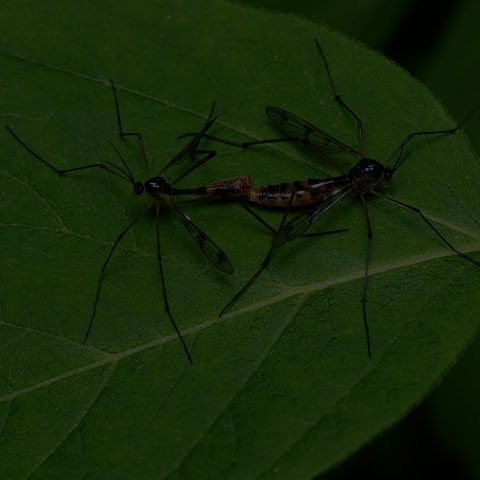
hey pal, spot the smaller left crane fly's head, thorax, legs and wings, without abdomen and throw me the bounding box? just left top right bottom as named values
left=6, top=80, right=233, bottom=363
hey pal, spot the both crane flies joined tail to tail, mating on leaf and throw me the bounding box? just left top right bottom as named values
left=7, top=40, right=480, bottom=362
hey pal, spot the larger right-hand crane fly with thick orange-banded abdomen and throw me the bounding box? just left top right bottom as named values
left=183, top=39, right=480, bottom=358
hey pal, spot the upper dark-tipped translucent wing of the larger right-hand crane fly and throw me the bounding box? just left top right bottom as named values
left=265, top=107, right=363, bottom=159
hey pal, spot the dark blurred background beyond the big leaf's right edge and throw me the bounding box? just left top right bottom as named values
left=238, top=0, right=480, bottom=480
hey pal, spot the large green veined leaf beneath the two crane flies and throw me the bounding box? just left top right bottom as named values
left=0, top=0, right=480, bottom=479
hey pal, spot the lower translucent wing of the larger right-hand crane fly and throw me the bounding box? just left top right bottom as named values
left=272, top=184, right=353, bottom=247
